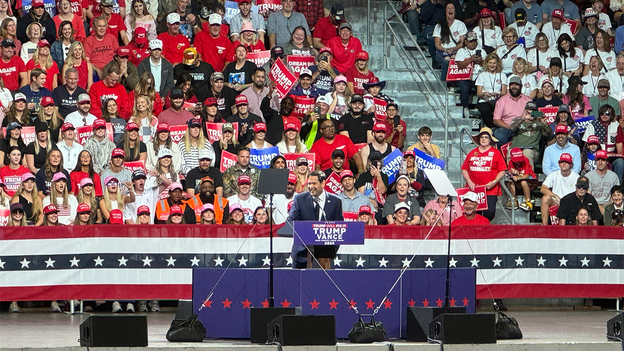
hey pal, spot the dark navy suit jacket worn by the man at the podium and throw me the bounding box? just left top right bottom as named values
left=288, top=192, right=344, bottom=268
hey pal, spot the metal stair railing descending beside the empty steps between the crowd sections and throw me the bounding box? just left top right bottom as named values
left=366, top=0, right=450, bottom=169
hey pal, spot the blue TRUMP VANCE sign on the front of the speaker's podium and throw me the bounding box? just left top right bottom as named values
left=294, top=221, right=364, bottom=245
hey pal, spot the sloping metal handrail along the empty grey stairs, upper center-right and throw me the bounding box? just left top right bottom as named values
left=378, top=0, right=450, bottom=169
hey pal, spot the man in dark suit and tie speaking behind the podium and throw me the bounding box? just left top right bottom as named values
left=288, top=171, right=344, bottom=269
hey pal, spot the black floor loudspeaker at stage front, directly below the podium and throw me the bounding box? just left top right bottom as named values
left=267, top=315, right=336, bottom=346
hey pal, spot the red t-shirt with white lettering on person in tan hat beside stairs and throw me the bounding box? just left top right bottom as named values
left=461, top=147, right=507, bottom=195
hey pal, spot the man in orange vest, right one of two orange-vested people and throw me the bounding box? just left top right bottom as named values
left=184, top=176, right=230, bottom=224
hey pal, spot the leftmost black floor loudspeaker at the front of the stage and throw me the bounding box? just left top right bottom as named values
left=80, top=316, right=147, bottom=347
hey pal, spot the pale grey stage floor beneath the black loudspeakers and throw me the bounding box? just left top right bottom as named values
left=0, top=310, right=622, bottom=351
